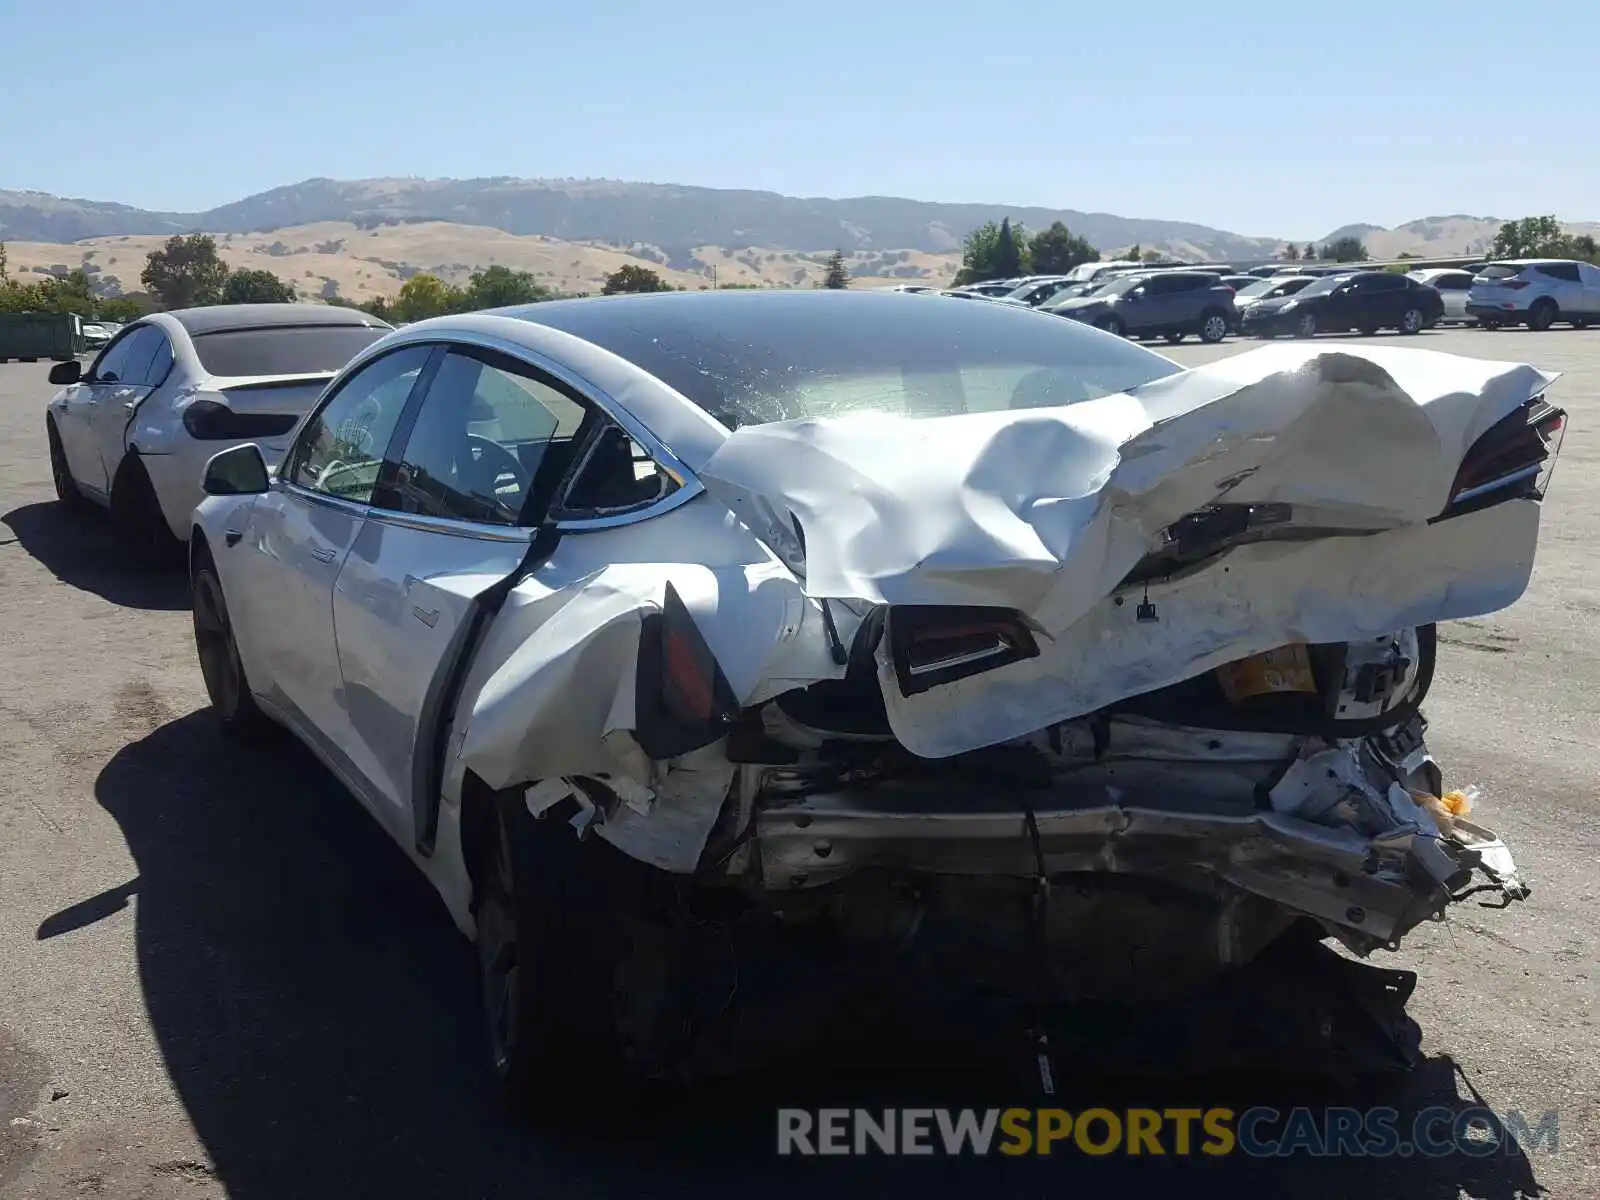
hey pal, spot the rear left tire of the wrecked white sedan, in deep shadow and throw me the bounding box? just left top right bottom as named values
left=472, top=790, right=650, bottom=1123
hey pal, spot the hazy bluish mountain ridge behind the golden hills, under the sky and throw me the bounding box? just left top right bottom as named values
left=0, top=176, right=1282, bottom=262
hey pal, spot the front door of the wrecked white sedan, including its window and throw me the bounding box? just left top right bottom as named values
left=221, top=344, right=434, bottom=780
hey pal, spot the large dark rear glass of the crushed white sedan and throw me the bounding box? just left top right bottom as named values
left=517, top=291, right=1181, bottom=429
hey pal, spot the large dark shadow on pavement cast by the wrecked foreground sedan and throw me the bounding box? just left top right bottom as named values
left=62, top=712, right=1541, bottom=1200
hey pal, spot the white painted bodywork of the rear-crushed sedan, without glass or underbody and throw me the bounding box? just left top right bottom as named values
left=195, top=314, right=1557, bottom=933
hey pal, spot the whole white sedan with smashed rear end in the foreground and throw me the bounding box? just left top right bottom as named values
left=190, top=293, right=1565, bottom=1101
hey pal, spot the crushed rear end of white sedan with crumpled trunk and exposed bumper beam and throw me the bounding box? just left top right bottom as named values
left=459, top=347, right=1565, bottom=1081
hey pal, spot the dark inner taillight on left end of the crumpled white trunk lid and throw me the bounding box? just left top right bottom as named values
left=888, top=606, right=1038, bottom=696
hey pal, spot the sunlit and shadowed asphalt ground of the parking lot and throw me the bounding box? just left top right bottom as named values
left=0, top=328, right=1600, bottom=1200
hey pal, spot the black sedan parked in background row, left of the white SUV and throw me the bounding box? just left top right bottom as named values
left=1240, top=270, right=1445, bottom=338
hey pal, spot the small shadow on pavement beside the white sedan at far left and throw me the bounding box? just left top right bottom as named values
left=0, top=501, right=189, bottom=611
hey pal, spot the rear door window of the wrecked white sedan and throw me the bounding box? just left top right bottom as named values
left=376, top=349, right=590, bottom=525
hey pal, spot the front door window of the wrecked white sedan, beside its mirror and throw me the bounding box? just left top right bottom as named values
left=285, top=346, right=432, bottom=504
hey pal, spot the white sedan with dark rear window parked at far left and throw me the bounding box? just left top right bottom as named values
left=45, top=304, right=390, bottom=560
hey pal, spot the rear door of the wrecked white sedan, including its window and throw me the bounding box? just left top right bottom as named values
left=333, top=344, right=598, bottom=853
